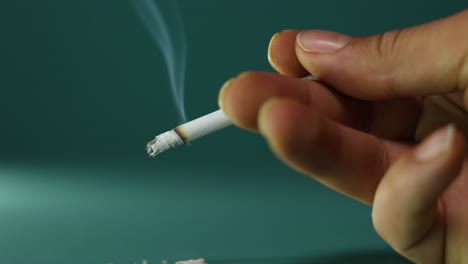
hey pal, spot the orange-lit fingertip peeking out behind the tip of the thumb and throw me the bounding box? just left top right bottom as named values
left=268, top=30, right=307, bottom=77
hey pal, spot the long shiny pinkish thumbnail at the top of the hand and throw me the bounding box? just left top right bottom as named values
left=296, top=30, right=351, bottom=53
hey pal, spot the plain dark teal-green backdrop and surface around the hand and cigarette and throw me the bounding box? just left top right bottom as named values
left=0, top=0, right=466, bottom=264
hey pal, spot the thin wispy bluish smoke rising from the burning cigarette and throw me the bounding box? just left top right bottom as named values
left=133, top=0, right=187, bottom=122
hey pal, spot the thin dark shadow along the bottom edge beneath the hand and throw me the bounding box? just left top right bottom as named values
left=214, top=251, right=412, bottom=264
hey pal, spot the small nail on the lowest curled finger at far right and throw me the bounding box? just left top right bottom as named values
left=415, top=124, right=455, bottom=161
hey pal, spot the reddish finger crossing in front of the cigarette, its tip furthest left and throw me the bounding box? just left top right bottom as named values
left=220, top=72, right=420, bottom=139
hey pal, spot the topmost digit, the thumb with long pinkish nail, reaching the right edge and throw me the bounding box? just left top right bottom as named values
left=296, top=9, right=468, bottom=101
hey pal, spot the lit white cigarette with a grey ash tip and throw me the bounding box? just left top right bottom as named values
left=146, top=75, right=318, bottom=157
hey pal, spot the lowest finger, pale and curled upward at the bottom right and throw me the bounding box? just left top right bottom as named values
left=372, top=125, right=464, bottom=263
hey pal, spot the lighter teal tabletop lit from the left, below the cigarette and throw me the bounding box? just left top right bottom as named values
left=0, top=161, right=407, bottom=264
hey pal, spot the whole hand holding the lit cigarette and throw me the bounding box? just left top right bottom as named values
left=220, top=10, right=468, bottom=264
